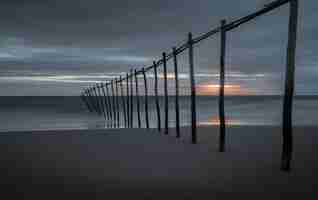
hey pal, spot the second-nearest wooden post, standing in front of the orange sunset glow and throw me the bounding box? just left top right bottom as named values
left=219, top=20, right=226, bottom=152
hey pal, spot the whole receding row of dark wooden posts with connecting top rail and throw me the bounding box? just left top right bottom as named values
left=81, top=0, right=298, bottom=171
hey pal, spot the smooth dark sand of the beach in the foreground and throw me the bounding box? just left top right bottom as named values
left=0, top=126, right=318, bottom=199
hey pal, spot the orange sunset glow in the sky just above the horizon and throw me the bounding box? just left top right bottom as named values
left=196, top=84, right=251, bottom=95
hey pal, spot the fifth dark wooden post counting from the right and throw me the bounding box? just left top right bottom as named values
left=162, top=52, right=169, bottom=134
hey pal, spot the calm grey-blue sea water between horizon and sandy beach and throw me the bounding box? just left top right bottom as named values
left=0, top=96, right=318, bottom=132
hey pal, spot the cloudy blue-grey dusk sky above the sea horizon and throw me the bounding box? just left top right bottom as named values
left=0, top=0, right=318, bottom=96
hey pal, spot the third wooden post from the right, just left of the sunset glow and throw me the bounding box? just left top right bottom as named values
left=188, top=33, right=197, bottom=144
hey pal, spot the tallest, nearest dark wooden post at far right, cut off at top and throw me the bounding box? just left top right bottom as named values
left=281, top=0, right=298, bottom=171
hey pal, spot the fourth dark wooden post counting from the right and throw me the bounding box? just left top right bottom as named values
left=173, top=47, right=180, bottom=138
